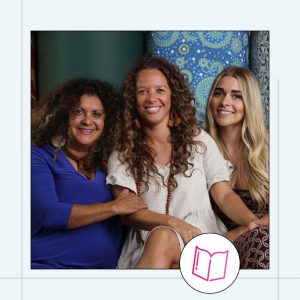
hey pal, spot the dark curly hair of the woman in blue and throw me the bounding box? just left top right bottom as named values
left=31, top=78, right=119, bottom=170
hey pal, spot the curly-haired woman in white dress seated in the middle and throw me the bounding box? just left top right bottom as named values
left=107, top=56, right=260, bottom=268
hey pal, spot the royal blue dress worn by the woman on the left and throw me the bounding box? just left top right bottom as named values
left=31, top=145, right=122, bottom=269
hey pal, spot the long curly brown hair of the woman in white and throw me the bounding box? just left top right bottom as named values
left=118, top=56, right=200, bottom=190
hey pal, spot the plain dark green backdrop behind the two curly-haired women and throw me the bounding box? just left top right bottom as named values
left=36, top=31, right=144, bottom=98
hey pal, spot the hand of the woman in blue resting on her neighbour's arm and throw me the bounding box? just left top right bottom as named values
left=112, top=188, right=147, bottom=215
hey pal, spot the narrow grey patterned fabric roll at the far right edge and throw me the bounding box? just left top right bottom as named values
left=250, top=31, right=270, bottom=127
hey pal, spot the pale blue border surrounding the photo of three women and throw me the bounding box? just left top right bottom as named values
left=0, top=0, right=300, bottom=300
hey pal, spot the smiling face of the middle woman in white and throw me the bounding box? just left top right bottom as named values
left=136, top=69, right=171, bottom=126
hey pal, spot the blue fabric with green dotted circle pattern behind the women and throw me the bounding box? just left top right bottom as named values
left=146, top=31, right=249, bottom=123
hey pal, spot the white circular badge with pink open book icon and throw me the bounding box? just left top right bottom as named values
left=180, top=233, right=240, bottom=294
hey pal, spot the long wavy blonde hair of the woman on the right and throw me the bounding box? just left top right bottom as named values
left=206, top=67, right=269, bottom=209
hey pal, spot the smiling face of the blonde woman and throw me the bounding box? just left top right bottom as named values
left=210, top=76, right=245, bottom=127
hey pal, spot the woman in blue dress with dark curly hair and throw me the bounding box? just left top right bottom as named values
left=31, top=79, right=146, bottom=269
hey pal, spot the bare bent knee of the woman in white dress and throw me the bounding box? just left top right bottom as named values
left=135, top=227, right=181, bottom=269
